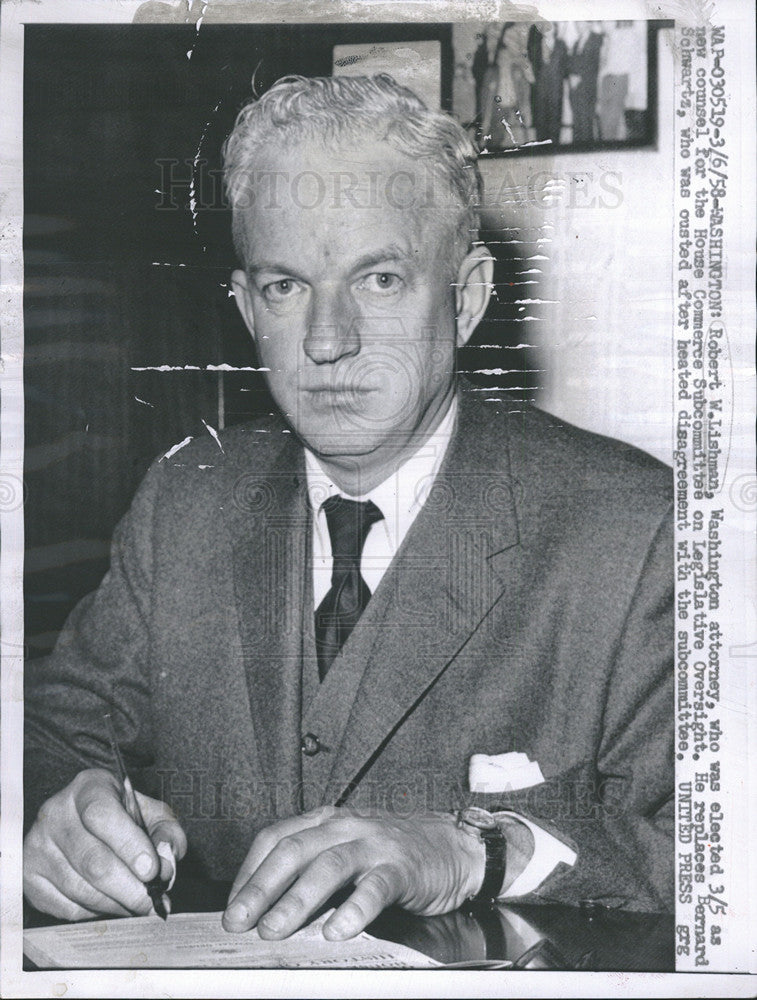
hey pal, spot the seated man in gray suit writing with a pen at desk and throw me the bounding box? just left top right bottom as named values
left=25, top=76, right=673, bottom=938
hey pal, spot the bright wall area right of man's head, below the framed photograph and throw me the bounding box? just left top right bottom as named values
left=482, top=22, right=675, bottom=463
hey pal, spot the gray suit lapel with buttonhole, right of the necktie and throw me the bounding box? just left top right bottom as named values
left=328, top=393, right=518, bottom=800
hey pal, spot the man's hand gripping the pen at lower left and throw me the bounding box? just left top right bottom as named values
left=24, top=769, right=187, bottom=920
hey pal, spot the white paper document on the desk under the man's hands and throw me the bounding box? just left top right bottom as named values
left=24, top=913, right=440, bottom=969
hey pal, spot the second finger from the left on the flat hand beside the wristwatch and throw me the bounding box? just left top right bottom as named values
left=258, top=841, right=365, bottom=940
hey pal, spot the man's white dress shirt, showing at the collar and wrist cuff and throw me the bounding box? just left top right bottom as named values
left=305, top=397, right=576, bottom=898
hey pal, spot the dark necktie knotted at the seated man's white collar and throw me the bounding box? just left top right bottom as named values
left=315, top=495, right=384, bottom=680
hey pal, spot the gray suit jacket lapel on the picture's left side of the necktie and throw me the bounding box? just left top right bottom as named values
left=226, top=436, right=309, bottom=808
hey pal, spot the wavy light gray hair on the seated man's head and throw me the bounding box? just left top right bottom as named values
left=223, top=73, right=481, bottom=269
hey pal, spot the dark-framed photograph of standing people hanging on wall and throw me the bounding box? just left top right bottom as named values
left=453, top=20, right=660, bottom=155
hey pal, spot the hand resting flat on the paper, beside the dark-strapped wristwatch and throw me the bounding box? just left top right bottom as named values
left=223, top=806, right=485, bottom=941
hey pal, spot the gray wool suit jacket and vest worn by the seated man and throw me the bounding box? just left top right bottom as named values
left=25, top=391, right=673, bottom=910
